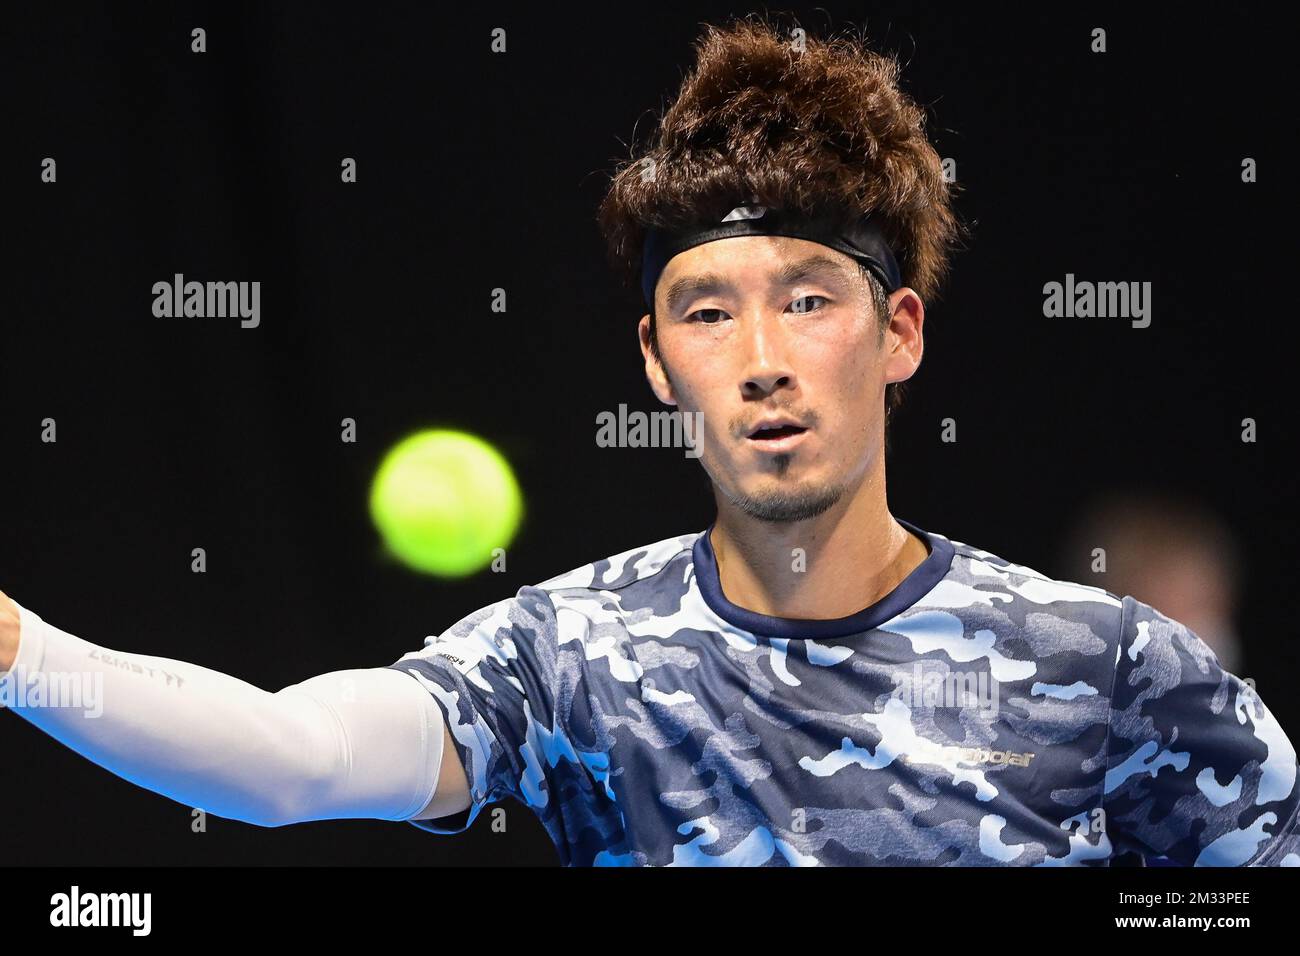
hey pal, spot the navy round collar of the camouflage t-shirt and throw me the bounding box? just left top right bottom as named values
left=692, top=518, right=953, bottom=640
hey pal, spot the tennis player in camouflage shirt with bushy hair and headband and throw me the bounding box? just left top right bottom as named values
left=0, top=21, right=1300, bottom=866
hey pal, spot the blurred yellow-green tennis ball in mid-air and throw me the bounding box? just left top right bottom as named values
left=371, top=429, right=524, bottom=578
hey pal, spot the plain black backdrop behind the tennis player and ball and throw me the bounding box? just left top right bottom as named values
left=0, top=4, right=1300, bottom=865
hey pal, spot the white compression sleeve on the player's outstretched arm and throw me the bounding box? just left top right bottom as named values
left=0, top=602, right=443, bottom=826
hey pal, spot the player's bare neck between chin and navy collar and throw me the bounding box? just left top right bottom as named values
left=710, top=467, right=928, bottom=620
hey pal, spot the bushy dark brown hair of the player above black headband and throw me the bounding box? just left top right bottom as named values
left=597, top=14, right=966, bottom=418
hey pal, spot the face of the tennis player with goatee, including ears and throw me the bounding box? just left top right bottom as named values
left=641, top=235, right=924, bottom=522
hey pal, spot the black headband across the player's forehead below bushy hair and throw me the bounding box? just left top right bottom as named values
left=641, top=198, right=902, bottom=311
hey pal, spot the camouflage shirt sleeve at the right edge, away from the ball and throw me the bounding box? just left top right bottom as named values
left=1102, top=596, right=1300, bottom=866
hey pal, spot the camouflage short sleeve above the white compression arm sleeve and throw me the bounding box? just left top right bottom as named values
left=389, top=587, right=558, bottom=834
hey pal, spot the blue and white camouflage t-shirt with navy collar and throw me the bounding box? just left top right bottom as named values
left=389, top=522, right=1300, bottom=866
